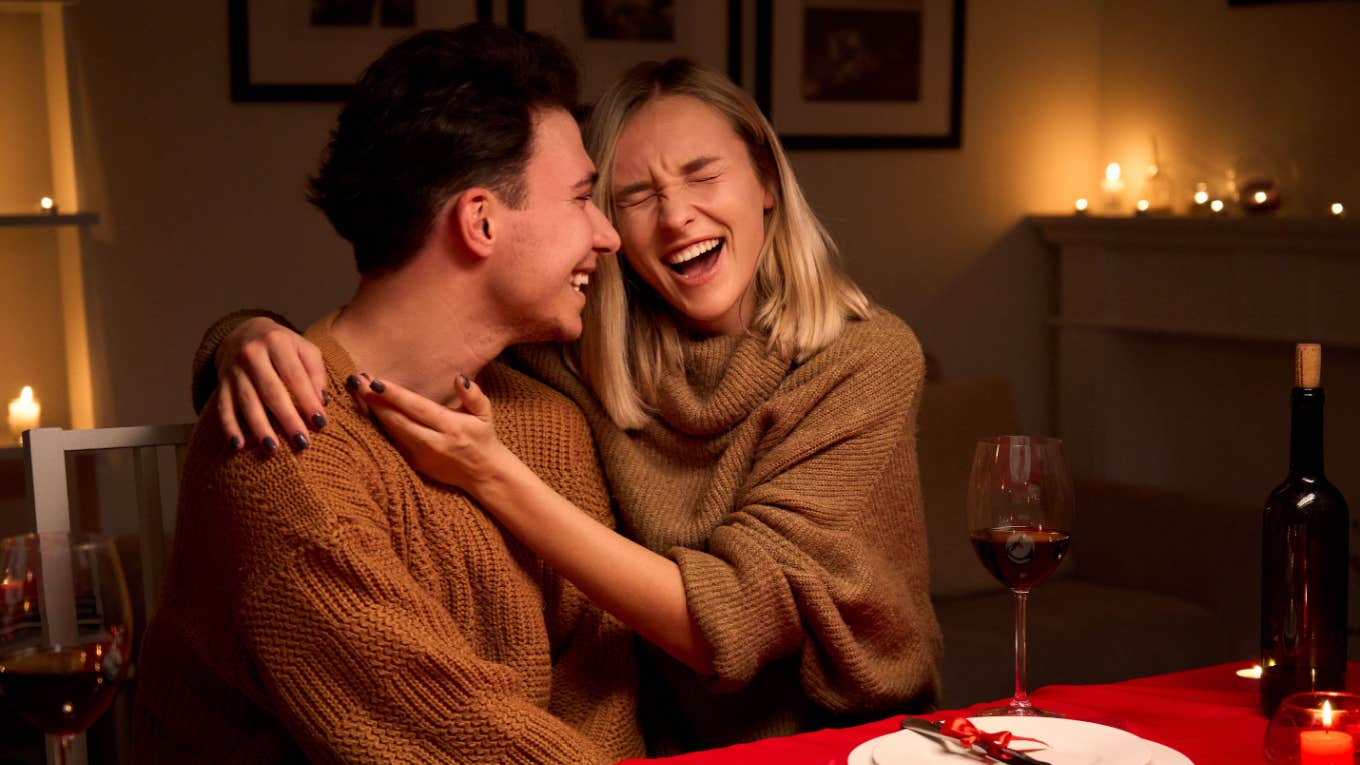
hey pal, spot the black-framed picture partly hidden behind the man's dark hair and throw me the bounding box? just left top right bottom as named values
left=227, top=0, right=492, bottom=101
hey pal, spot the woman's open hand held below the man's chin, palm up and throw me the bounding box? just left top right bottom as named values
left=359, top=376, right=518, bottom=497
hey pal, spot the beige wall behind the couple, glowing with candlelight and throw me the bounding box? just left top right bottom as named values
left=2, top=0, right=1360, bottom=451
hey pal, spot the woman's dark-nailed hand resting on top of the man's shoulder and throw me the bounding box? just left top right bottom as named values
left=208, top=316, right=326, bottom=453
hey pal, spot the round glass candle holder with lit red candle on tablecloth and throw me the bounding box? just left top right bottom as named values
left=1266, top=690, right=1360, bottom=765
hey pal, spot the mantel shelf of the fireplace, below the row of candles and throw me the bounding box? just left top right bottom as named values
left=1030, top=215, right=1360, bottom=253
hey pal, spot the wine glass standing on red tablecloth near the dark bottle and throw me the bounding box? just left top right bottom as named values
left=968, top=436, right=1073, bottom=716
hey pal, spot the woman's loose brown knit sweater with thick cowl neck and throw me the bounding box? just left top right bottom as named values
left=511, top=309, right=941, bottom=754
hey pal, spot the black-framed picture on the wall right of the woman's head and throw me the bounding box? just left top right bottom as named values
left=756, top=0, right=964, bottom=148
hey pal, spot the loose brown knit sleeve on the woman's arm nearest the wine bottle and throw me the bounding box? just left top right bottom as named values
left=670, top=324, right=941, bottom=713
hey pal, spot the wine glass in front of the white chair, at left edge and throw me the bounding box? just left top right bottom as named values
left=0, top=534, right=132, bottom=764
